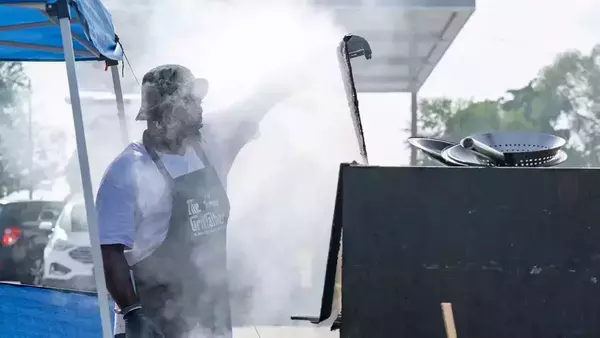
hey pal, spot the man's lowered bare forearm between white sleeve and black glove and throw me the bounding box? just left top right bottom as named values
left=101, top=244, right=139, bottom=309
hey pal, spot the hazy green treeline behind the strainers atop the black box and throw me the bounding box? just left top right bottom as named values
left=417, top=45, right=600, bottom=166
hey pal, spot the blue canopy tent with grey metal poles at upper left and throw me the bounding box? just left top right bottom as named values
left=0, top=0, right=128, bottom=338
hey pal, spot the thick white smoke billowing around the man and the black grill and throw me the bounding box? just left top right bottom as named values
left=29, top=0, right=359, bottom=334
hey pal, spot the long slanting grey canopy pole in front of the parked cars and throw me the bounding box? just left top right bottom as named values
left=57, top=0, right=113, bottom=338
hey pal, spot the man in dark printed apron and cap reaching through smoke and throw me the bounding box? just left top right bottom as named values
left=96, top=65, right=294, bottom=338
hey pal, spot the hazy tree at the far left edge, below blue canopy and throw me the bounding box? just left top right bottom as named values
left=0, top=62, right=31, bottom=194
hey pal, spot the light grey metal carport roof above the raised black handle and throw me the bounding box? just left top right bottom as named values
left=315, top=0, right=475, bottom=92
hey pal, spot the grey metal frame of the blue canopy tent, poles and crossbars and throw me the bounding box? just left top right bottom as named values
left=0, top=0, right=129, bottom=338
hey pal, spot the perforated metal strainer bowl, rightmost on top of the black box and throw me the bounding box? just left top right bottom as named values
left=462, top=132, right=566, bottom=167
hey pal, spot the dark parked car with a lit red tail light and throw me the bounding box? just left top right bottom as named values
left=0, top=201, right=64, bottom=284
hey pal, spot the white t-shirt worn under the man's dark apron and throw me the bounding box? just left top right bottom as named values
left=96, top=115, right=256, bottom=265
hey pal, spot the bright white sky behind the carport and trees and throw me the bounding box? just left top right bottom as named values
left=22, top=0, right=600, bottom=165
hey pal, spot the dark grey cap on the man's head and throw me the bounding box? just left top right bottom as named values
left=135, top=64, right=208, bottom=121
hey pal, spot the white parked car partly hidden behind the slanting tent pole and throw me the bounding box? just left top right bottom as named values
left=41, top=199, right=96, bottom=291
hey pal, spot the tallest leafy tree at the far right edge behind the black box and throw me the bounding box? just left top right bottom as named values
left=500, top=45, right=600, bottom=166
